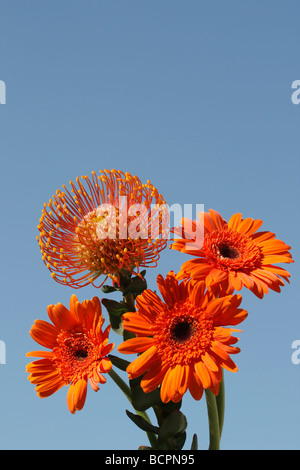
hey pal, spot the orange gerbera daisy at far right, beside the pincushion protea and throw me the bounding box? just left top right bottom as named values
left=171, top=210, right=293, bottom=298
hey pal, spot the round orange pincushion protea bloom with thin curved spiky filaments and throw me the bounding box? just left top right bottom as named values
left=37, top=170, right=168, bottom=288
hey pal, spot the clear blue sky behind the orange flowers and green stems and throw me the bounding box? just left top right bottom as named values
left=0, top=0, right=300, bottom=449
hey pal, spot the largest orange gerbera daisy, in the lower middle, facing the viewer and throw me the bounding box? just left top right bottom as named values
left=118, top=272, right=247, bottom=403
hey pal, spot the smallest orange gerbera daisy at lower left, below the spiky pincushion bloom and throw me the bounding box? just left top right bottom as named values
left=26, top=295, right=114, bottom=413
